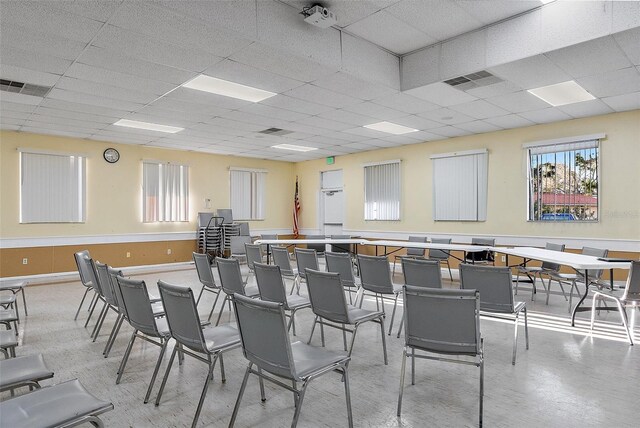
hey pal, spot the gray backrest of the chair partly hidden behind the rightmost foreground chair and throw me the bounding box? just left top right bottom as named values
left=460, top=263, right=514, bottom=313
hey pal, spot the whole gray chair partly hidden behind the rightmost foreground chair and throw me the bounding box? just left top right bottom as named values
left=460, top=263, right=529, bottom=365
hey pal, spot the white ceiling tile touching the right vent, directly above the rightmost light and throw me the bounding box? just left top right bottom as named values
left=489, top=55, right=571, bottom=89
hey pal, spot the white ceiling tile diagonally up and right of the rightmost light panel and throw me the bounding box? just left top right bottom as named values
left=545, top=37, right=640, bottom=77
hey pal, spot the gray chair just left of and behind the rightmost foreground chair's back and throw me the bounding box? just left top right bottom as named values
left=358, top=255, right=402, bottom=334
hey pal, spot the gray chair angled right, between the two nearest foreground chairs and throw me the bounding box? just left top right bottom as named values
left=306, top=269, right=387, bottom=364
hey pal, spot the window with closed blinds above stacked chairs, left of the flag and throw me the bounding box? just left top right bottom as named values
left=229, top=168, right=267, bottom=220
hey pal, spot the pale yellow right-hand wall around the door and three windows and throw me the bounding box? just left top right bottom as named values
left=295, top=110, right=640, bottom=241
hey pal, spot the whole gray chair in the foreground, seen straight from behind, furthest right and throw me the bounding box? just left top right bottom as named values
left=397, top=285, right=484, bottom=426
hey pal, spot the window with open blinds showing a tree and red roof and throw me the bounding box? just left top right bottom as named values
left=525, top=135, right=604, bottom=221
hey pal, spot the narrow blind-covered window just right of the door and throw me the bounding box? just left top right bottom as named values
left=364, top=160, right=400, bottom=220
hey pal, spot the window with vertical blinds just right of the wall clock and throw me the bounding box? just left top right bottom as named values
left=142, top=161, right=189, bottom=223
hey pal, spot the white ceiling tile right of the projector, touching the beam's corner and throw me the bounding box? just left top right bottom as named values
left=346, top=11, right=437, bottom=55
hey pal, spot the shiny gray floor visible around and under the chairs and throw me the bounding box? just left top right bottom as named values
left=0, top=268, right=640, bottom=428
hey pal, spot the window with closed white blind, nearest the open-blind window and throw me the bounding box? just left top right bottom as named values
left=431, top=149, right=488, bottom=221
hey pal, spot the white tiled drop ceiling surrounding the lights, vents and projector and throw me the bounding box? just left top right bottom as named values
left=0, top=0, right=640, bottom=162
